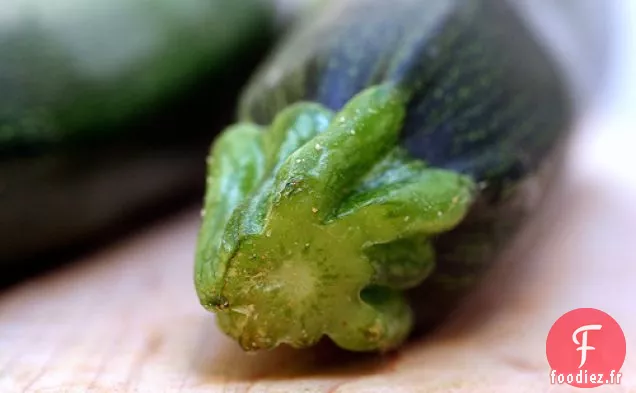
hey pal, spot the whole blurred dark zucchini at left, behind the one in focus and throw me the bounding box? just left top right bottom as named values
left=0, top=0, right=275, bottom=266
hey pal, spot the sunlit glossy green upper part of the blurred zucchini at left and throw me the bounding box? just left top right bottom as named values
left=0, top=0, right=271, bottom=150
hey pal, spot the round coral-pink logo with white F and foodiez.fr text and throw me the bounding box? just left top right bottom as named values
left=546, top=308, right=627, bottom=388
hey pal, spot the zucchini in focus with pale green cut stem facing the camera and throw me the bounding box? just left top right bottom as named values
left=194, top=0, right=573, bottom=351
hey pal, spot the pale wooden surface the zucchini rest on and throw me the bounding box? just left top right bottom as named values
left=0, top=2, right=636, bottom=393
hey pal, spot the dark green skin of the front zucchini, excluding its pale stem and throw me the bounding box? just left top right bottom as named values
left=240, top=0, right=573, bottom=327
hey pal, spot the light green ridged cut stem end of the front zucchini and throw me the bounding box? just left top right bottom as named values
left=196, top=85, right=476, bottom=351
